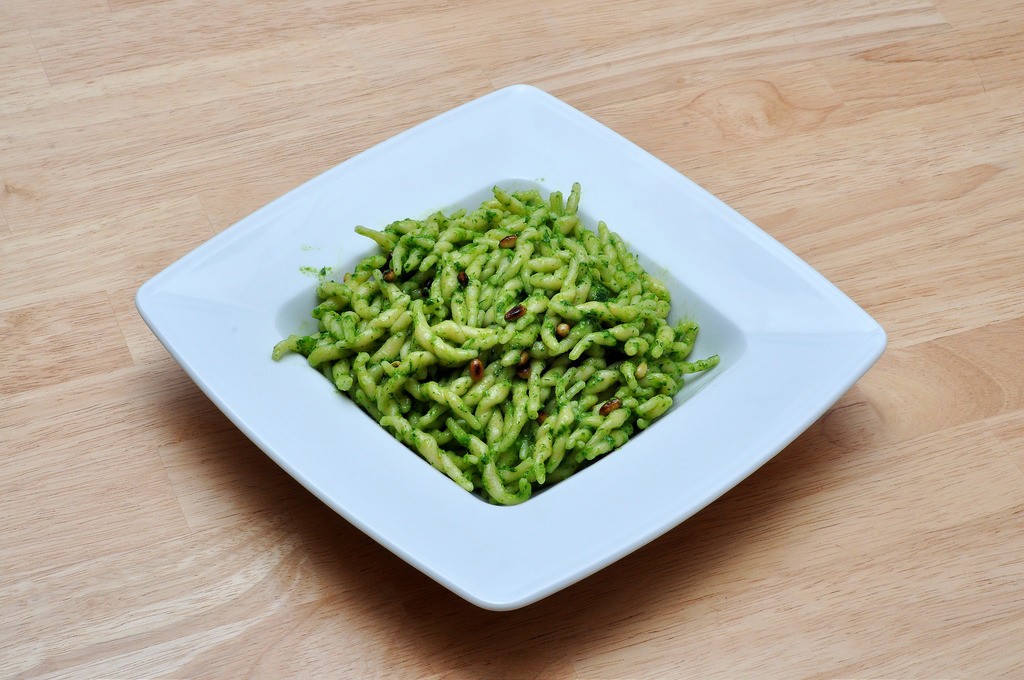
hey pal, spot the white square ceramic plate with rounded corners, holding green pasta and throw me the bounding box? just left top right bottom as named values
left=136, top=85, right=886, bottom=609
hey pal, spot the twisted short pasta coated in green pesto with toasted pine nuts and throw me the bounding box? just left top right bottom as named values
left=272, top=183, right=719, bottom=505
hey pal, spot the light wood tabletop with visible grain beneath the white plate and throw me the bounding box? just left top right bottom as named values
left=0, top=0, right=1024, bottom=678
